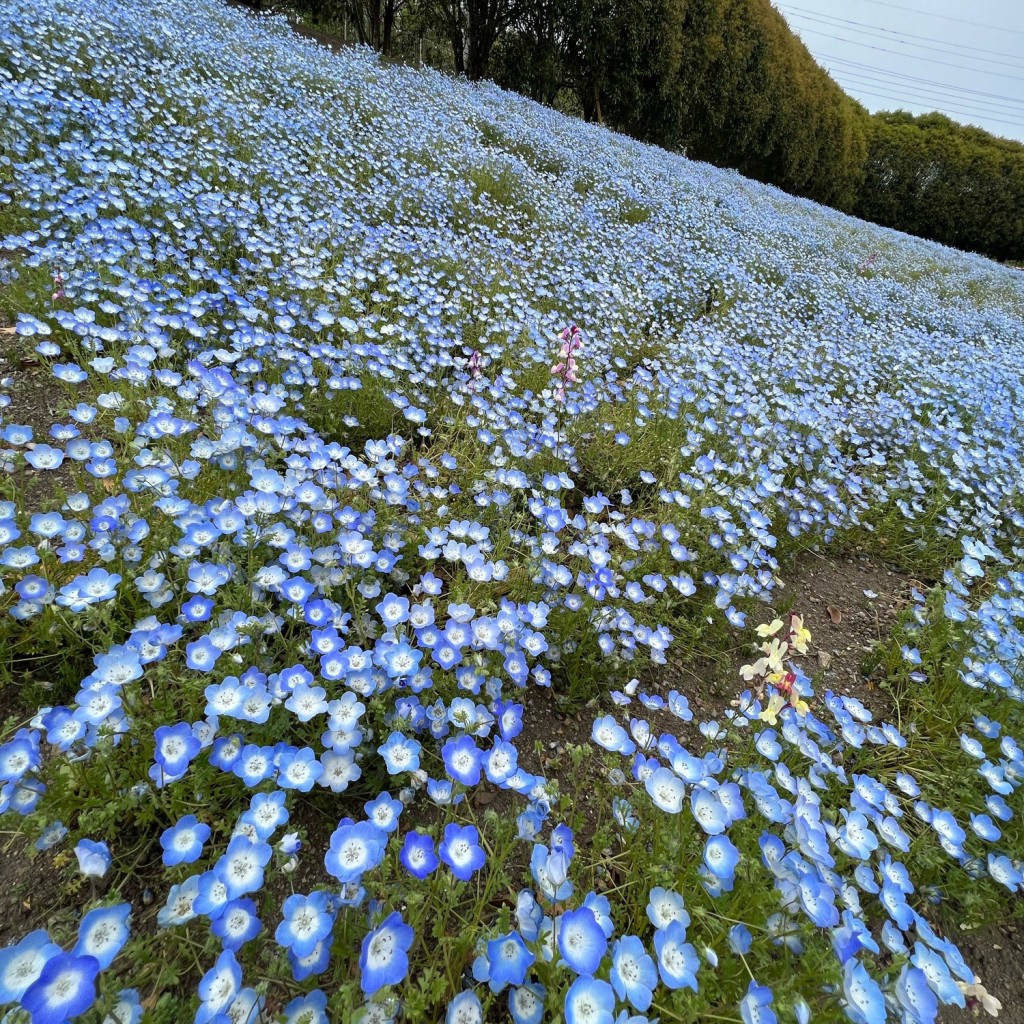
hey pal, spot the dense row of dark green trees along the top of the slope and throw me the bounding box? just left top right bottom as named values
left=253, top=0, right=1024, bottom=259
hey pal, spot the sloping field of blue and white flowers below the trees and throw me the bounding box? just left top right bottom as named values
left=0, top=0, right=1024, bottom=1024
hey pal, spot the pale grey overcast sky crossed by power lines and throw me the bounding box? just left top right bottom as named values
left=773, top=0, right=1024, bottom=141
